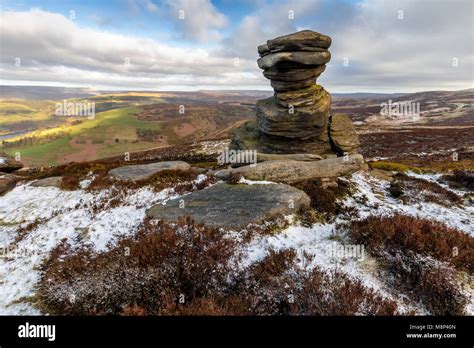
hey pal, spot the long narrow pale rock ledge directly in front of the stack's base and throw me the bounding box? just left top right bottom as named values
left=216, top=154, right=368, bottom=183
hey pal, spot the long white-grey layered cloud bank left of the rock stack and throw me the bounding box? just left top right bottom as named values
left=0, top=9, right=262, bottom=89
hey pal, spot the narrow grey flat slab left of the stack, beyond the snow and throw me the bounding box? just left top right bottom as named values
left=108, top=161, right=191, bottom=180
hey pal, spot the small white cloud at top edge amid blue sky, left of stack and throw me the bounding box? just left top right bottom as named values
left=166, top=0, right=228, bottom=42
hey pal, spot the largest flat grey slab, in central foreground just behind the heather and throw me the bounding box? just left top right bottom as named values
left=146, top=183, right=310, bottom=229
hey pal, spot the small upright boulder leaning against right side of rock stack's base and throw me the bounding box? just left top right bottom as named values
left=329, top=114, right=359, bottom=155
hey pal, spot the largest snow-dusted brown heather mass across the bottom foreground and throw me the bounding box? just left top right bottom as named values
left=37, top=218, right=397, bottom=315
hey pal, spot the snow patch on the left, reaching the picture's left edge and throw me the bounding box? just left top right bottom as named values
left=0, top=175, right=206, bottom=315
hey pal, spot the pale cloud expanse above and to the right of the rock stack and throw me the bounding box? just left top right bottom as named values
left=219, top=0, right=474, bottom=92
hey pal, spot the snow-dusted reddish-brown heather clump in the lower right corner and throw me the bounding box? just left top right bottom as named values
left=350, top=215, right=474, bottom=315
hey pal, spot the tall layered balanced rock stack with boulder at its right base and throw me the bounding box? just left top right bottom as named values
left=231, top=30, right=358, bottom=155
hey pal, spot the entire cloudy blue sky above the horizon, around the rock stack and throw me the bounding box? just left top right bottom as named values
left=0, top=0, right=474, bottom=93
